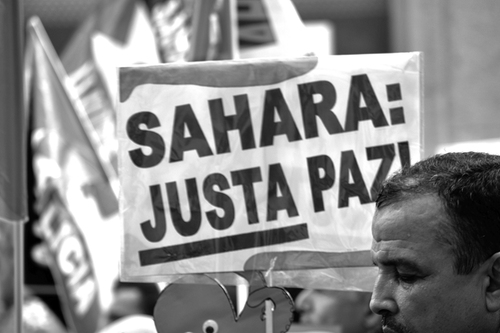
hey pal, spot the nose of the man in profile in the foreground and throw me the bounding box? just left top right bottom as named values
left=370, top=273, right=398, bottom=315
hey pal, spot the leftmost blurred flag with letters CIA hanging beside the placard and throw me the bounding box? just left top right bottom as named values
left=27, top=18, right=119, bottom=333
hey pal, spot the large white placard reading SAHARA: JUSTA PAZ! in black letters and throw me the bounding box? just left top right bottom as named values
left=117, top=52, right=422, bottom=287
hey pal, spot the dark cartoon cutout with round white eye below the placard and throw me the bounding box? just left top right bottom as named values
left=154, top=276, right=293, bottom=333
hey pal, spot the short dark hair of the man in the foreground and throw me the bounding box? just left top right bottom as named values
left=376, top=152, right=500, bottom=274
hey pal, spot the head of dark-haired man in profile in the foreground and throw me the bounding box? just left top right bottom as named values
left=371, top=153, right=500, bottom=333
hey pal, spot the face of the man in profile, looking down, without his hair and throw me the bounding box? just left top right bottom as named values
left=370, top=196, right=490, bottom=333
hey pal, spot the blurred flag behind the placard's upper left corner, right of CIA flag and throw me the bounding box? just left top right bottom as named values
left=61, top=0, right=158, bottom=176
